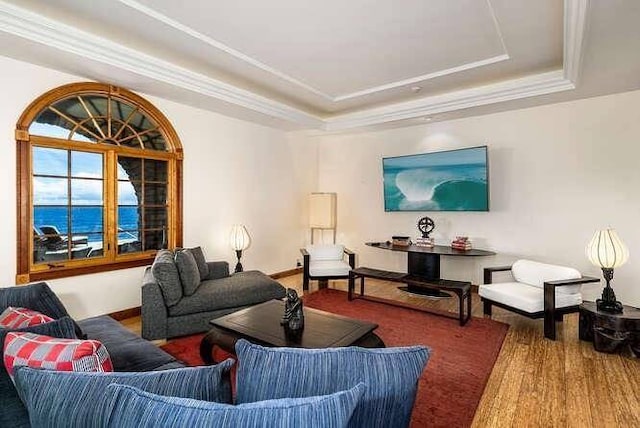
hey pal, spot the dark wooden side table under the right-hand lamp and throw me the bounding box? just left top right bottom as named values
left=578, top=302, right=640, bottom=357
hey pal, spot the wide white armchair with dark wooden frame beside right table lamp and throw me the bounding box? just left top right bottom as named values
left=478, top=260, right=600, bottom=340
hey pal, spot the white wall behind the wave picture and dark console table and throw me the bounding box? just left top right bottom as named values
left=311, top=91, right=640, bottom=306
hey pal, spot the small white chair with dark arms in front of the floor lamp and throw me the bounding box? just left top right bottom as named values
left=300, top=244, right=355, bottom=291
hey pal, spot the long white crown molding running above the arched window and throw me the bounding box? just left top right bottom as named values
left=0, top=1, right=323, bottom=128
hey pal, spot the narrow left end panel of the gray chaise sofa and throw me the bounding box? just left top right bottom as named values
left=140, top=267, right=168, bottom=340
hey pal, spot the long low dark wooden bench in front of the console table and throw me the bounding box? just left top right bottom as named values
left=349, top=267, right=471, bottom=325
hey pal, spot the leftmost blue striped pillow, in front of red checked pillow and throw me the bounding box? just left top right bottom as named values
left=15, top=359, right=234, bottom=428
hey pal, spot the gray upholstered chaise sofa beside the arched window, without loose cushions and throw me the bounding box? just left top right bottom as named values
left=142, top=250, right=286, bottom=340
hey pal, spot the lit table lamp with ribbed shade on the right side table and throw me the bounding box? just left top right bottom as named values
left=586, top=229, right=629, bottom=313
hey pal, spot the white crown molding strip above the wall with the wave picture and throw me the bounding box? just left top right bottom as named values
left=325, top=70, right=575, bottom=131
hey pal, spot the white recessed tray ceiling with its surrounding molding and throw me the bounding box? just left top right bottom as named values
left=0, top=0, right=636, bottom=129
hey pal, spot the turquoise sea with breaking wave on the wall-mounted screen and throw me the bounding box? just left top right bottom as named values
left=384, top=163, right=488, bottom=211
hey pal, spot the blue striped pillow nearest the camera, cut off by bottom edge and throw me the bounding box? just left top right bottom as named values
left=105, top=383, right=365, bottom=428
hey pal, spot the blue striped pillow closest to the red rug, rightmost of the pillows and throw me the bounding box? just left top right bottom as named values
left=236, top=340, right=430, bottom=427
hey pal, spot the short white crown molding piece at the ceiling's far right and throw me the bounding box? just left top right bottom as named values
left=563, top=0, right=589, bottom=84
